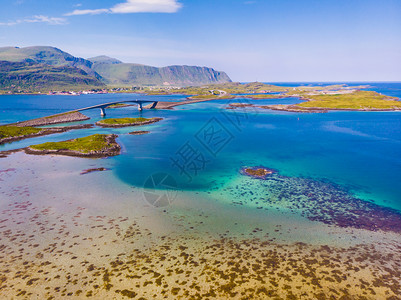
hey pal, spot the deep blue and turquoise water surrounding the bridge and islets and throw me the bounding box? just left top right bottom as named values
left=0, top=83, right=401, bottom=210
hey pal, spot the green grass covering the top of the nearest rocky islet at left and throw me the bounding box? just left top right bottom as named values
left=30, top=134, right=108, bottom=153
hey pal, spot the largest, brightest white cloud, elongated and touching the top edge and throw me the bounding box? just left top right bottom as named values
left=66, top=0, right=182, bottom=16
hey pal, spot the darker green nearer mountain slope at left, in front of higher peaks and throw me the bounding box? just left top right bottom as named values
left=0, top=61, right=105, bottom=92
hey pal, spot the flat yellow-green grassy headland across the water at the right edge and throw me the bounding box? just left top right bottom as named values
left=296, top=91, right=401, bottom=109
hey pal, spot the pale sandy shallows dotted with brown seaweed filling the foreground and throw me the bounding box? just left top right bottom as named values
left=0, top=153, right=401, bottom=299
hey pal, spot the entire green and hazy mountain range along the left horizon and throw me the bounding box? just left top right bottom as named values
left=0, top=46, right=231, bottom=91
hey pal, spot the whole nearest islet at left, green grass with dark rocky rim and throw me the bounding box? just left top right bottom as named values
left=24, top=134, right=121, bottom=158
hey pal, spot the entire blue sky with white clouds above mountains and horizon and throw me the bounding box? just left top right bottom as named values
left=0, top=0, right=401, bottom=82
